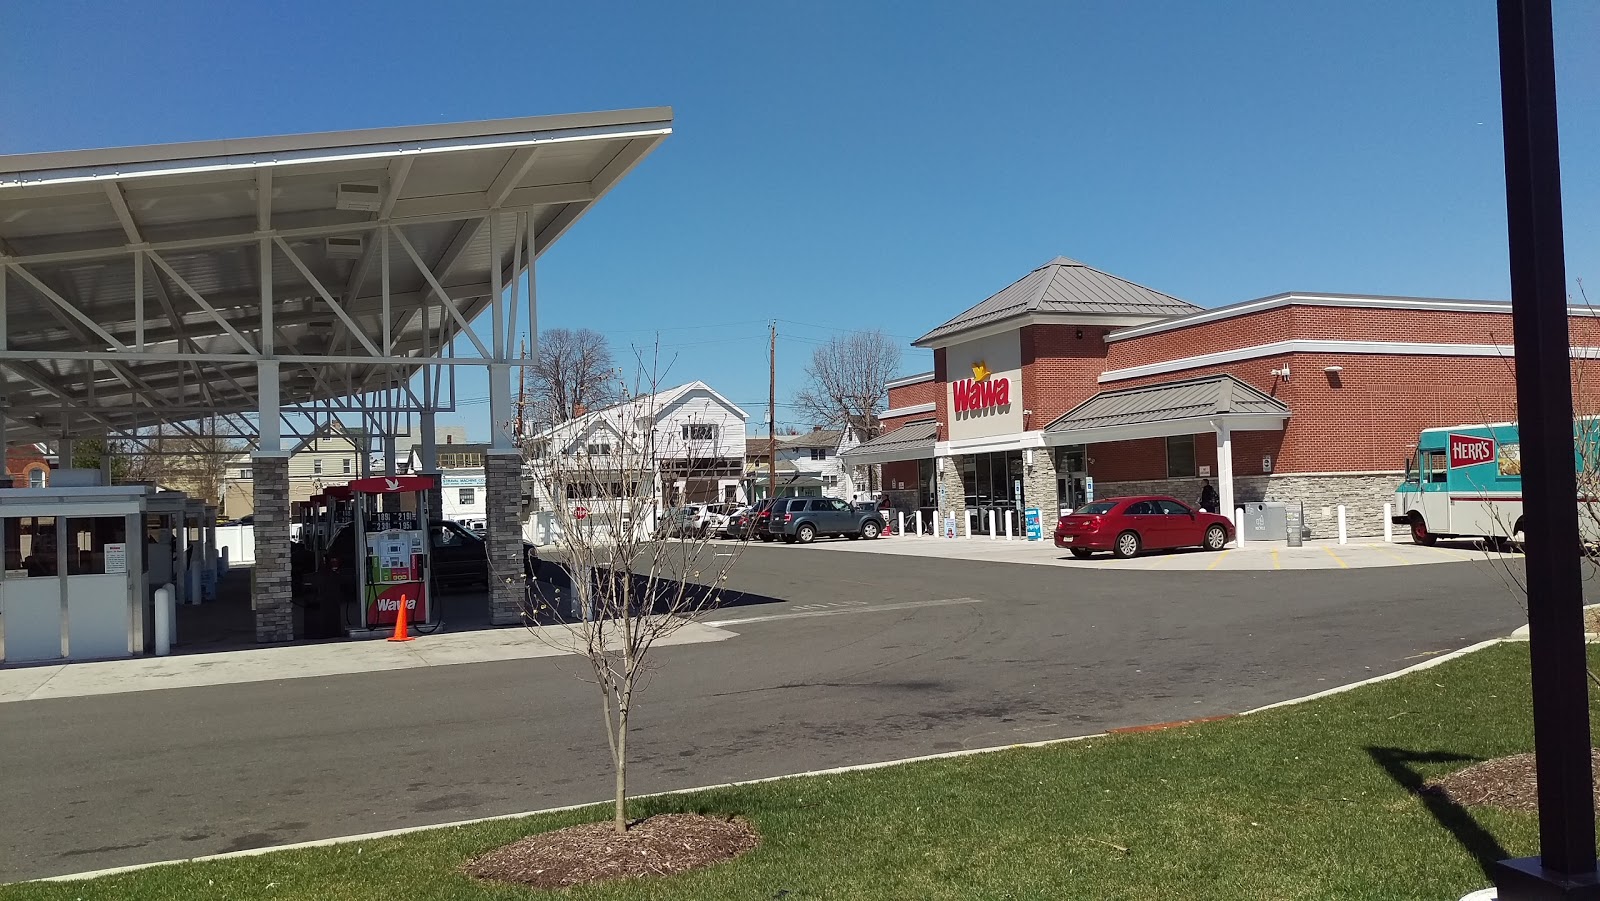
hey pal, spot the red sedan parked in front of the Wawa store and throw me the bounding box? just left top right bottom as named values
left=1056, top=495, right=1234, bottom=559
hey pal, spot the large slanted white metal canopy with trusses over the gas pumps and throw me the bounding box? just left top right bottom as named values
left=0, top=107, right=672, bottom=440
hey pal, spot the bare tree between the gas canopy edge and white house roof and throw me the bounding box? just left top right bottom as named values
left=523, top=328, right=621, bottom=434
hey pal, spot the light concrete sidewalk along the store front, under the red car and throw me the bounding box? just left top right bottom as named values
left=780, top=535, right=1485, bottom=571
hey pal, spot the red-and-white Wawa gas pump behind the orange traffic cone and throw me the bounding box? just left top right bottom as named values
left=349, top=475, right=437, bottom=632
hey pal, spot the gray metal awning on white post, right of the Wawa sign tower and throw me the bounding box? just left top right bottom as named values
left=1045, top=374, right=1290, bottom=445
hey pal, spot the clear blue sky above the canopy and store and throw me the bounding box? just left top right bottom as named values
left=0, top=0, right=1600, bottom=437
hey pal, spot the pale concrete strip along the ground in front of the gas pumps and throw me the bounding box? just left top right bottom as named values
left=0, top=623, right=734, bottom=703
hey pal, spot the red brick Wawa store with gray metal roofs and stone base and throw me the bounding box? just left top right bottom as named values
left=850, top=258, right=1600, bottom=535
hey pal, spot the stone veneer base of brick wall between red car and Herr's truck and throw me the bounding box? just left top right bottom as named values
left=1094, top=471, right=1405, bottom=538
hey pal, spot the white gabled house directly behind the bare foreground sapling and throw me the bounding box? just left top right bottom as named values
left=526, top=381, right=749, bottom=544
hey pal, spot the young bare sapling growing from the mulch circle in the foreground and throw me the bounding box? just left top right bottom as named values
left=525, top=348, right=744, bottom=834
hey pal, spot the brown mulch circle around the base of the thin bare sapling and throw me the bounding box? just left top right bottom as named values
left=462, top=813, right=762, bottom=888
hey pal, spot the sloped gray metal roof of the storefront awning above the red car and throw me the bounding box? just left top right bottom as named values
left=1045, top=374, right=1290, bottom=432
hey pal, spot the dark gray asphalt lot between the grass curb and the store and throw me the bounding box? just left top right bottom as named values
left=0, top=544, right=1542, bottom=880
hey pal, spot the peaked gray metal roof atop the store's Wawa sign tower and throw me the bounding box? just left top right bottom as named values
left=912, top=256, right=1200, bottom=346
